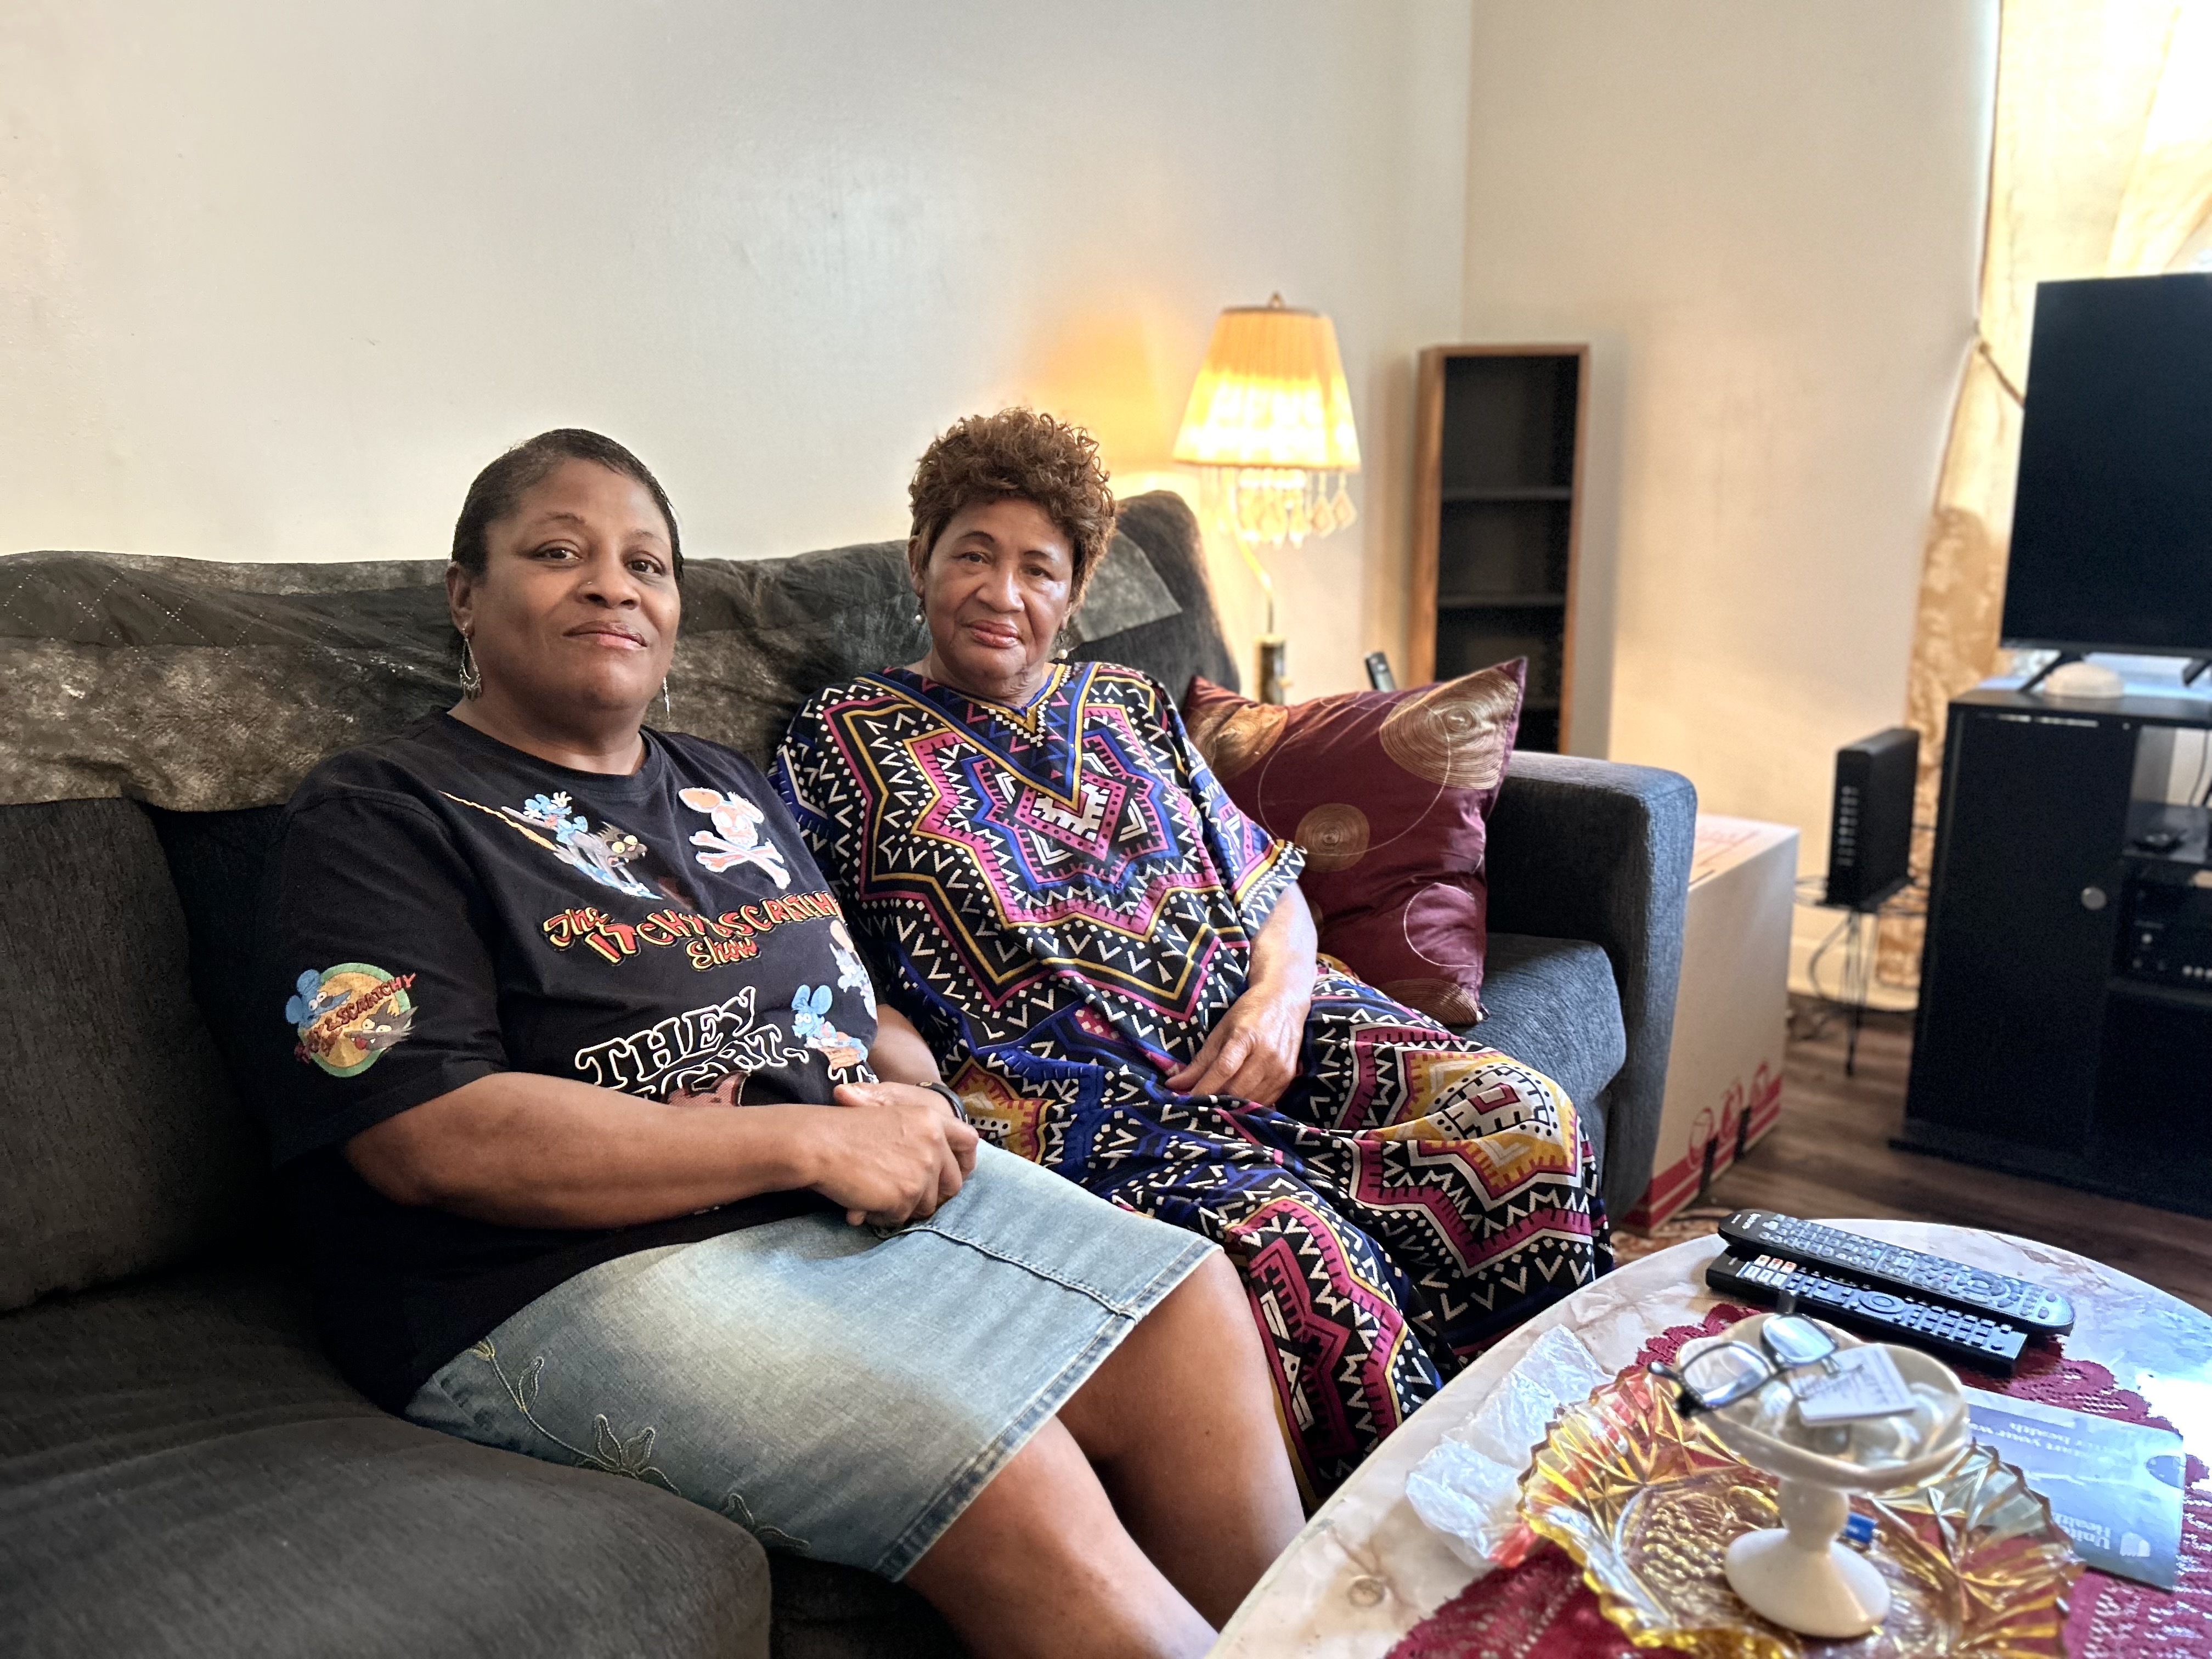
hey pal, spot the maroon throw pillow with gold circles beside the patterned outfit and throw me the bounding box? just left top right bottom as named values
left=1183, top=659, right=1528, bottom=1024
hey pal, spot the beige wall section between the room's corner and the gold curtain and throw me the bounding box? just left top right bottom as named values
left=1464, top=0, right=1997, bottom=870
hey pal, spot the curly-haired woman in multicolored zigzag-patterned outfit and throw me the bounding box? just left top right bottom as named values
left=774, top=409, right=1610, bottom=1500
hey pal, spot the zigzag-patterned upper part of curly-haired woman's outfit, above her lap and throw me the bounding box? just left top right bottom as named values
left=776, top=664, right=1296, bottom=1053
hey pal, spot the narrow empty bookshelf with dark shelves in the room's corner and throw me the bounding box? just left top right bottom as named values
left=1409, top=345, right=1590, bottom=752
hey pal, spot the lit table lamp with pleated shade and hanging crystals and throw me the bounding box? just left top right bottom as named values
left=1175, top=294, right=1361, bottom=703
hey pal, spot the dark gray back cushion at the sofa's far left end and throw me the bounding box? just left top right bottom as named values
left=0, top=801, right=266, bottom=1310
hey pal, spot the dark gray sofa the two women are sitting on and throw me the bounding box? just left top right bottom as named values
left=0, top=495, right=1695, bottom=1659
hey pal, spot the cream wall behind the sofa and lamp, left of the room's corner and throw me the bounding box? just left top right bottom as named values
left=0, top=0, right=1469, bottom=692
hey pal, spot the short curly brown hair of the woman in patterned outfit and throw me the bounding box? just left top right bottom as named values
left=907, top=409, right=1115, bottom=600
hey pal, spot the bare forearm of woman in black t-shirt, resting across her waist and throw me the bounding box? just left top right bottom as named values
left=345, top=1070, right=840, bottom=1228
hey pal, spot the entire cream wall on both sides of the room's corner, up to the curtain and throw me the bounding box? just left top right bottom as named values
left=13, top=0, right=2026, bottom=814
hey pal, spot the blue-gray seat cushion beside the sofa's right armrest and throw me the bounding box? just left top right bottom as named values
left=1464, top=934, right=1628, bottom=1148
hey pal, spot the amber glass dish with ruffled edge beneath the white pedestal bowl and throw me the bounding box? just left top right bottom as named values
left=1522, top=1369, right=2081, bottom=1659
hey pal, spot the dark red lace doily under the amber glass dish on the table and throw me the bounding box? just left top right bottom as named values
left=1389, top=1303, right=2212, bottom=1659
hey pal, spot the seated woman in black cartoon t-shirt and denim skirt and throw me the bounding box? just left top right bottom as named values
left=259, top=431, right=1299, bottom=1655
